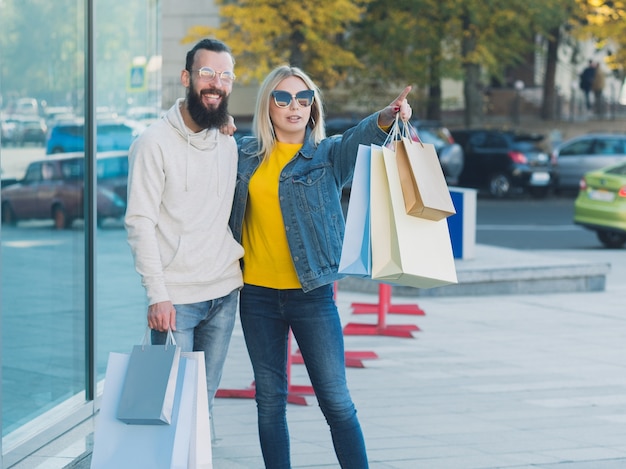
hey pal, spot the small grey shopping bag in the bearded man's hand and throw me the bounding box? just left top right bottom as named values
left=117, top=331, right=180, bottom=425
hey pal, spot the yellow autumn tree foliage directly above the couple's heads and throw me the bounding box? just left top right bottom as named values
left=182, top=0, right=371, bottom=88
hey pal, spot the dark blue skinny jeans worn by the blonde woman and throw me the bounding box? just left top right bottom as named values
left=239, top=285, right=368, bottom=469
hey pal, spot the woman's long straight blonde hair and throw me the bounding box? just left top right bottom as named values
left=252, top=65, right=326, bottom=159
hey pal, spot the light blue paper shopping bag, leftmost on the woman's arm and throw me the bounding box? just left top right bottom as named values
left=339, top=145, right=372, bottom=277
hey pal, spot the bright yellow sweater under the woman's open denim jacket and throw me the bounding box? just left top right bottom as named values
left=241, top=142, right=302, bottom=290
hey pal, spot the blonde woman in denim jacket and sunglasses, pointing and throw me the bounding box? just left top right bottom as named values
left=230, top=66, right=411, bottom=469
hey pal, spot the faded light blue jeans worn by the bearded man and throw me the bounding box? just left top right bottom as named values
left=152, top=290, right=239, bottom=415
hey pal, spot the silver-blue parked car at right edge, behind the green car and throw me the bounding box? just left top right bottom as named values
left=552, top=133, right=626, bottom=191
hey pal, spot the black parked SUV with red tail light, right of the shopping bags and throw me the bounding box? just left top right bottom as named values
left=451, top=129, right=554, bottom=197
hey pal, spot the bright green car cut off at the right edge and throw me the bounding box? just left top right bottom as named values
left=574, top=163, right=626, bottom=248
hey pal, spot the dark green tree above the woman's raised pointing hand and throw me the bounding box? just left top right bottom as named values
left=348, top=0, right=462, bottom=119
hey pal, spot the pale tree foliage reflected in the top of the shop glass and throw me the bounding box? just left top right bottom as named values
left=0, top=0, right=157, bottom=110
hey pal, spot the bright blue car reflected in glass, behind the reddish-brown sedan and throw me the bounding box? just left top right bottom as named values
left=46, top=119, right=145, bottom=154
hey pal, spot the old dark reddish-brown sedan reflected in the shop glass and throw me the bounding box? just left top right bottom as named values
left=0, top=152, right=128, bottom=229
